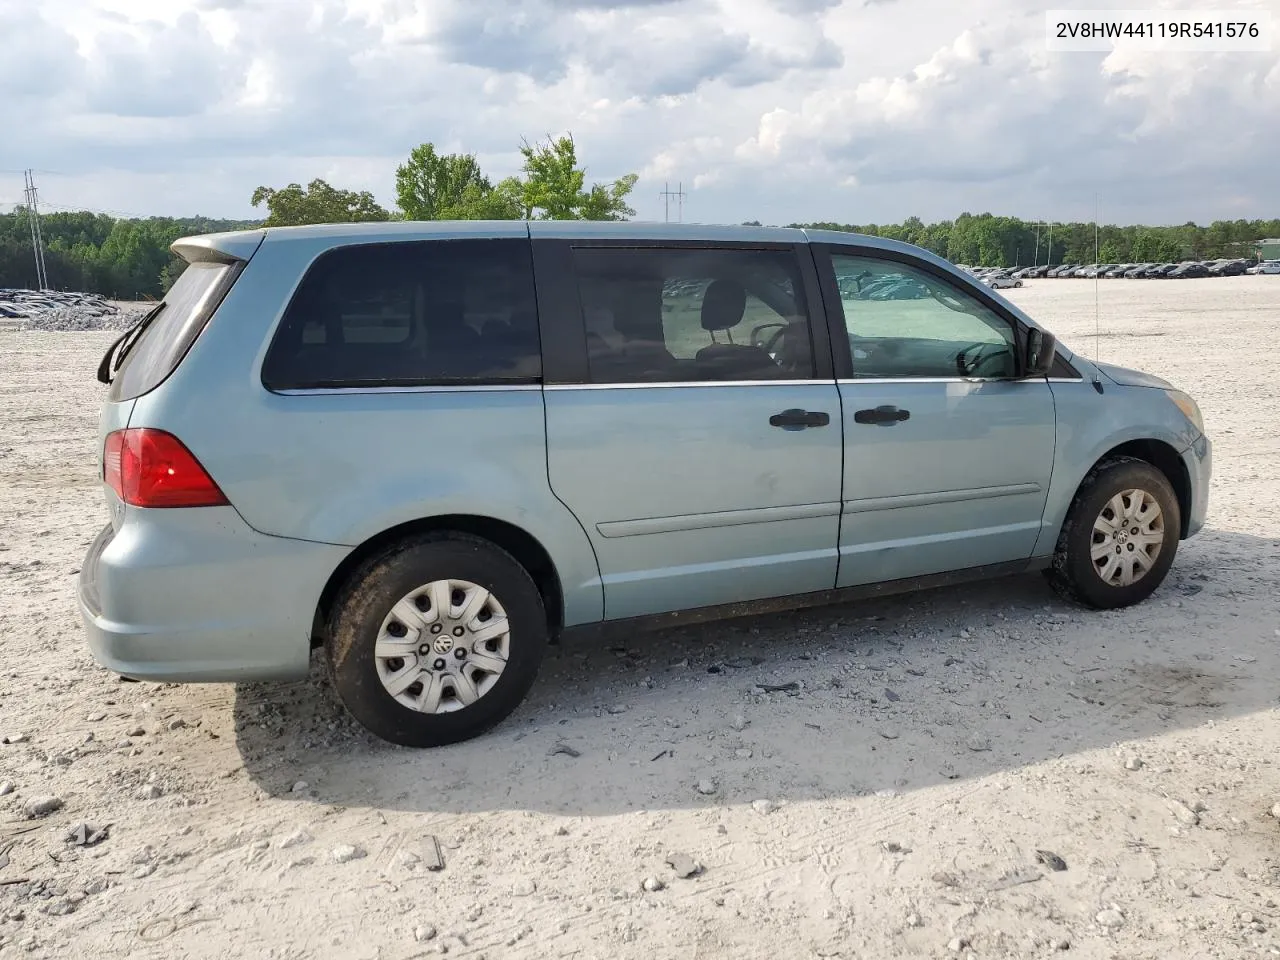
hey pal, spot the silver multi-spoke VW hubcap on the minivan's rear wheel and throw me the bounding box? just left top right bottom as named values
left=374, top=580, right=511, bottom=713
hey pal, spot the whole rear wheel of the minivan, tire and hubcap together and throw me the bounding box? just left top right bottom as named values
left=325, top=532, right=548, bottom=748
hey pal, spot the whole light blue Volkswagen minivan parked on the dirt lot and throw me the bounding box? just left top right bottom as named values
left=79, top=221, right=1211, bottom=746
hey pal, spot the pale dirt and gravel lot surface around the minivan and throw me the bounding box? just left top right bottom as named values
left=0, top=276, right=1280, bottom=960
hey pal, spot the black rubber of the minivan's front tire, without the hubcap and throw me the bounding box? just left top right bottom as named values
left=1056, top=460, right=1181, bottom=609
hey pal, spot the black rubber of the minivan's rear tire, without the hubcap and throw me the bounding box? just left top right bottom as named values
left=326, top=535, right=548, bottom=746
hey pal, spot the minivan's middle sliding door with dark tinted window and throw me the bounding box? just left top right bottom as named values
left=535, top=233, right=844, bottom=620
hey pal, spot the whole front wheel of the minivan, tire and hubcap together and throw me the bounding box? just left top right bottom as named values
left=1044, top=457, right=1183, bottom=609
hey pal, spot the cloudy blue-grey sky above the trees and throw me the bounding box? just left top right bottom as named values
left=0, top=0, right=1280, bottom=224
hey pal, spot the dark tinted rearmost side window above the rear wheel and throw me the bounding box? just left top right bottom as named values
left=262, top=239, right=541, bottom=390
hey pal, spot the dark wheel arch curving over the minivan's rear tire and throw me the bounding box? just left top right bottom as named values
left=311, top=513, right=564, bottom=646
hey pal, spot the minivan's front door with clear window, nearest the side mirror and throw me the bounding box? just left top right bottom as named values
left=817, top=246, right=1055, bottom=586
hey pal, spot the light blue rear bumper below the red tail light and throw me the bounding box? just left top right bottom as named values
left=79, top=507, right=349, bottom=682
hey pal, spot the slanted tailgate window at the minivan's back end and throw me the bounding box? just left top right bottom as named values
left=108, top=261, right=236, bottom=401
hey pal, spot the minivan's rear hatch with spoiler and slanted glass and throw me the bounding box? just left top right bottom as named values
left=97, top=230, right=265, bottom=530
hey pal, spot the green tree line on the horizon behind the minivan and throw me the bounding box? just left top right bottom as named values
left=0, top=134, right=1280, bottom=298
